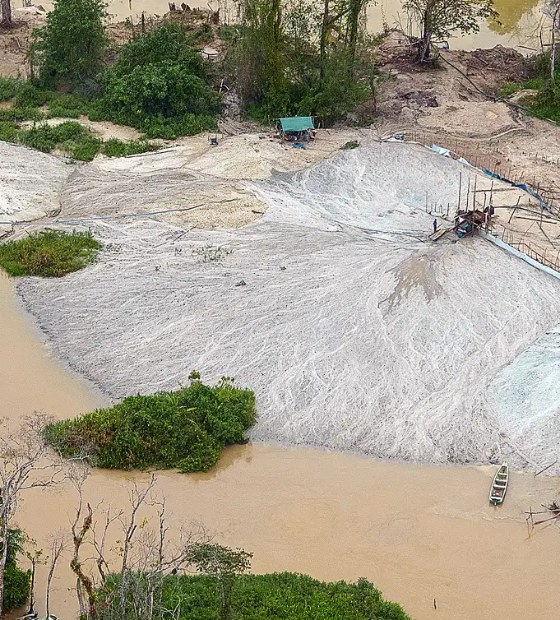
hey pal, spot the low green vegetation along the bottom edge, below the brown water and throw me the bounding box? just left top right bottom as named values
left=99, top=573, right=410, bottom=620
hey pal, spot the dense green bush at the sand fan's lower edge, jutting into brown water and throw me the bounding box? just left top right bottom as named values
left=45, top=373, right=255, bottom=472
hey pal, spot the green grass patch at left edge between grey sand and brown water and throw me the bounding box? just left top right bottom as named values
left=0, top=230, right=100, bottom=278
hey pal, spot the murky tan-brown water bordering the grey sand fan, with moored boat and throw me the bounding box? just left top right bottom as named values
left=0, top=278, right=560, bottom=620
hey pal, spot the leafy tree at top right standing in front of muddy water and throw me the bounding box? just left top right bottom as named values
left=403, top=0, right=498, bottom=62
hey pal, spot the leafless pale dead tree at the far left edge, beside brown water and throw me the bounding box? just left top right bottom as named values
left=0, top=414, right=64, bottom=613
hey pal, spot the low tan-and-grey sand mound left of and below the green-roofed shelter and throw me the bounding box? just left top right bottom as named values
left=62, top=149, right=266, bottom=229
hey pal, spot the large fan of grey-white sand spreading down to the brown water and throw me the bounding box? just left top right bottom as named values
left=6, top=143, right=560, bottom=468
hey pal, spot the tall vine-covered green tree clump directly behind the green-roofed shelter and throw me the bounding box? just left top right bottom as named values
left=222, top=0, right=376, bottom=125
